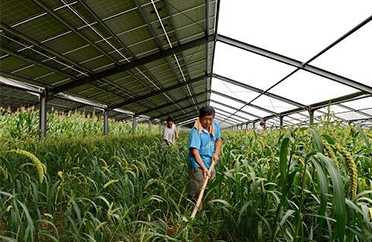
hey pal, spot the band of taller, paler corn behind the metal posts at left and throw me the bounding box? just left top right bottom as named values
left=0, top=107, right=159, bottom=145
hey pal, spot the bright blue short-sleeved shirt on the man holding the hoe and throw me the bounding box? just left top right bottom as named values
left=188, top=120, right=221, bottom=169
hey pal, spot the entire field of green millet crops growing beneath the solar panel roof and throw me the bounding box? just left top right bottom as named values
left=0, top=110, right=372, bottom=241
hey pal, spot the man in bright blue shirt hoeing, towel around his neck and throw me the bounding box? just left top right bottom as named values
left=188, top=106, right=222, bottom=204
